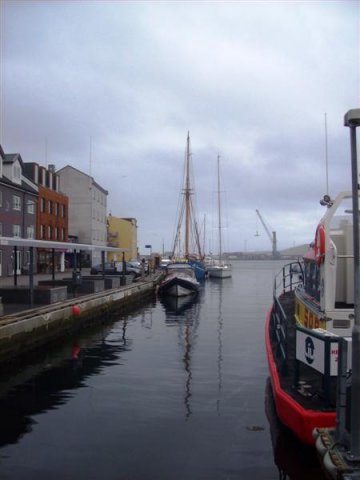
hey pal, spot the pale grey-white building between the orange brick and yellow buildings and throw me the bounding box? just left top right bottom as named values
left=56, top=165, right=108, bottom=265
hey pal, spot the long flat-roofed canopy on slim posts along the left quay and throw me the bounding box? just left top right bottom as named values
left=0, top=236, right=128, bottom=306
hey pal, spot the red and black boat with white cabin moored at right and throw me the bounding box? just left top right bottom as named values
left=265, top=192, right=354, bottom=445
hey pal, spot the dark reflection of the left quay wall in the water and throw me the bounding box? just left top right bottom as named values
left=0, top=320, right=131, bottom=447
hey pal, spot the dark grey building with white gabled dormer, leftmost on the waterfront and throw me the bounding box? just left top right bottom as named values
left=0, top=145, right=38, bottom=276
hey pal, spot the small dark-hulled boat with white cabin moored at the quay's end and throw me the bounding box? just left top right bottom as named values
left=158, top=263, right=200, bottom=297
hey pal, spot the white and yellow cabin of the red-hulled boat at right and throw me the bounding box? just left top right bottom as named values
left=295, top=192, right=354, bottom=336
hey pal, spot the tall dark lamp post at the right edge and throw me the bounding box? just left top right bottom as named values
left=344, top=108, right=360, bottom=461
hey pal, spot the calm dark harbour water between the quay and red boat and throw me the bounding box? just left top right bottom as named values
left=0, top=261, right=323, bottom=480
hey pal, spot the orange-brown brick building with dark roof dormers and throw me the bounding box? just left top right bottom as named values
left=24, top=162, right=69, bottom=272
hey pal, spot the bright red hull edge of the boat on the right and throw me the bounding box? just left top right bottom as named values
left=265, top=308, right=336, bottom=446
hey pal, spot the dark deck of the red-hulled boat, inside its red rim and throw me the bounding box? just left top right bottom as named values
left=270, top=291, right=336, bottom=411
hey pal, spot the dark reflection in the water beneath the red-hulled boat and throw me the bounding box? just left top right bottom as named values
left=265, top=378, right=326, bottom=480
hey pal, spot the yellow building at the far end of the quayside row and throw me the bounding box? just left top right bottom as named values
left=107, top=214, right=138, bottom=262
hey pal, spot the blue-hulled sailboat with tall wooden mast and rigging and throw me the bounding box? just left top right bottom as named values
left=171, top=132, right=206, bottom=280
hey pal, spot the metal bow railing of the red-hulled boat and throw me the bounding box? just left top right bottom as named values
left=271, top=261, right=304, bottom=375
